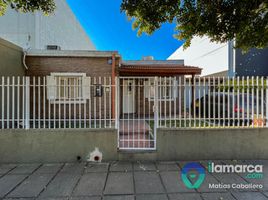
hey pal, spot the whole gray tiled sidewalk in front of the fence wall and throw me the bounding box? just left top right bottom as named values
left=0, top=161, right=268, bottom=200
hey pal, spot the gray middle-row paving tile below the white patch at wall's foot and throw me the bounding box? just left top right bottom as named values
left=72, top=173, right=107, bottom=196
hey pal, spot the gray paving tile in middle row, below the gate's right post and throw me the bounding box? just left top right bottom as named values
left=134, top=172, right=165, bottom=194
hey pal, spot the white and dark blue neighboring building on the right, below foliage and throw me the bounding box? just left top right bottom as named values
left=168, top=37, right=268, bottom=77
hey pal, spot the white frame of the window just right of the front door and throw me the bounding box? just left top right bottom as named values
left=144, top=77, right=178, bottom=101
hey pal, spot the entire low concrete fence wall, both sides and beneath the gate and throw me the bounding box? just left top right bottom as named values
left=0, top=128, right=268, bottom=163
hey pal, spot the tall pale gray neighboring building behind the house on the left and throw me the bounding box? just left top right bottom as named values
left=0, top=0, right=95, bottom=50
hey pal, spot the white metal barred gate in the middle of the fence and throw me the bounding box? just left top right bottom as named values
left=117, top=77, right=158, bottom=150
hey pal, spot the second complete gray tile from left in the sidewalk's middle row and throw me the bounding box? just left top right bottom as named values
left=40, top=173, right=80, bottom=198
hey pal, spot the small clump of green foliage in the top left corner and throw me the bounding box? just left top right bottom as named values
left=0, top=0, right=56, bottom=16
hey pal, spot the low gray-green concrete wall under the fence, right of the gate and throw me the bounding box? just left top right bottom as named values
left=157, top=128, right=268, bottom=160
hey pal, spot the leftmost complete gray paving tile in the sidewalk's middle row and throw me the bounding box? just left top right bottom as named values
left=8, top=174, right=54, bottom=198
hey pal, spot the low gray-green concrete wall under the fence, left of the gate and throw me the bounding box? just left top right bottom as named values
left=0, top=129, right=117, bottom=163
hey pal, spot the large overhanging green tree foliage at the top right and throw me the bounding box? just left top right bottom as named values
left=121, top=0, right=268, bottom=51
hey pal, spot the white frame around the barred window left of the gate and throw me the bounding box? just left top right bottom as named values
left=47, top=72, right=90, bottom=104
